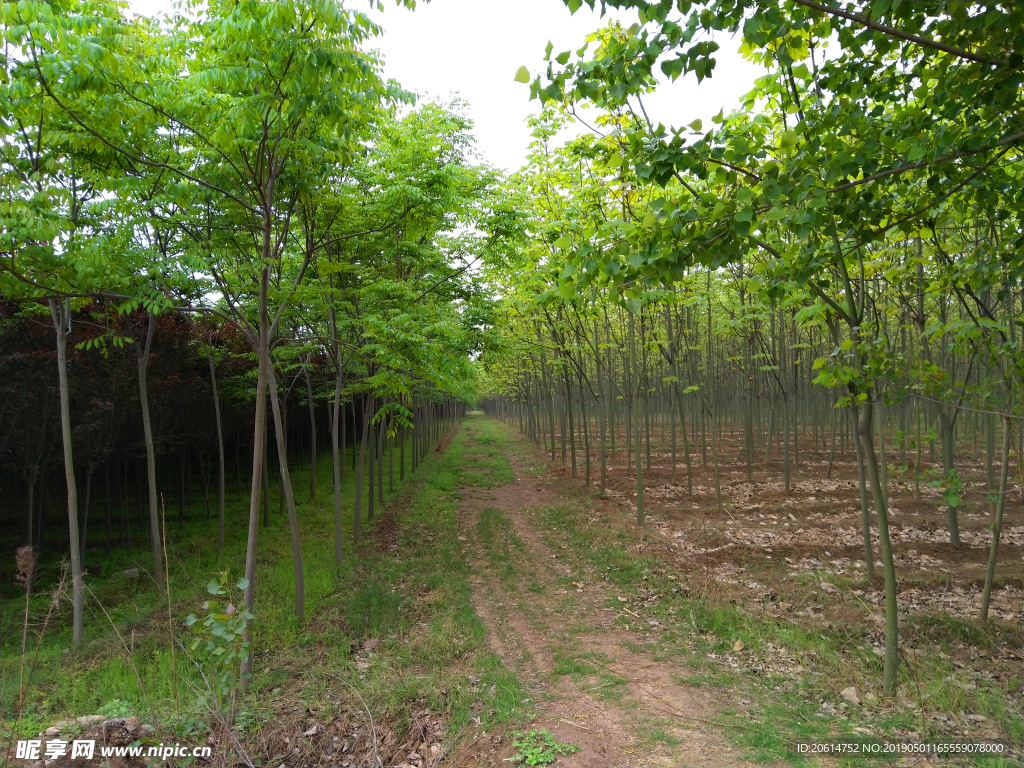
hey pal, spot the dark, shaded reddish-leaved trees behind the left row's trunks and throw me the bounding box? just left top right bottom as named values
left=0, top=306, right=464, bottom=568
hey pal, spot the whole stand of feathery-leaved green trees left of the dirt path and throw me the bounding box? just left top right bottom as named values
left=0, top=0, right=507, bottom=675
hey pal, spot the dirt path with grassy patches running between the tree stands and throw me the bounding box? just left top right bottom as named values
left=454, top=422, right=742, bottom=766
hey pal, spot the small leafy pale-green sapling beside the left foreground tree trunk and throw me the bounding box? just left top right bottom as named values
left=185, top=569, right=252, bottom=712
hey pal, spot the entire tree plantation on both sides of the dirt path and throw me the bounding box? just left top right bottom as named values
left=0, top=0, right=1024, bottom=720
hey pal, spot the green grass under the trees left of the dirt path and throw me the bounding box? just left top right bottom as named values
left=0, top=415, right=529, bottom=757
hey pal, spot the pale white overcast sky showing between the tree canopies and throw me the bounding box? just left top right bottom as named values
left=130, top=0, right=763, bottom=171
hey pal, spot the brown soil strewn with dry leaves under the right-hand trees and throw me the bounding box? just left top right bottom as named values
left=598, top=440, right=1024, bottom=651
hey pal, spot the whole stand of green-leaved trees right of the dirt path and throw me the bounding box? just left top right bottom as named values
left=484, top=0, right=1024, bottom=690
